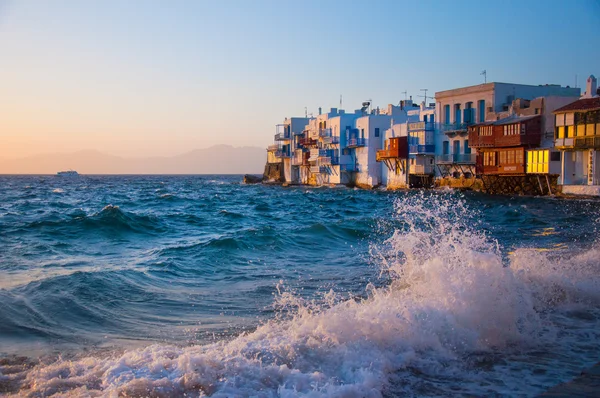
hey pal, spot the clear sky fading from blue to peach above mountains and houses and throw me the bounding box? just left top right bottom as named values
left=0, top=0, right=600, bottom=158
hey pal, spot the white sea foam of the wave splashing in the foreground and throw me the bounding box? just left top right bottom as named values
left=5, top=195, right=600, bottom=397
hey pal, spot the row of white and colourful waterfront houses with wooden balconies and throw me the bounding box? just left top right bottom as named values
left=265, top=76, right=600, bottom=195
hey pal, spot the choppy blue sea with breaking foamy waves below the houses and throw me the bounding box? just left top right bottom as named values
left=0, top=175, right=600, bottom=397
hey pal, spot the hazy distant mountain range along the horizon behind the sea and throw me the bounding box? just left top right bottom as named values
left=0, top=145, right=267, bottom=174
